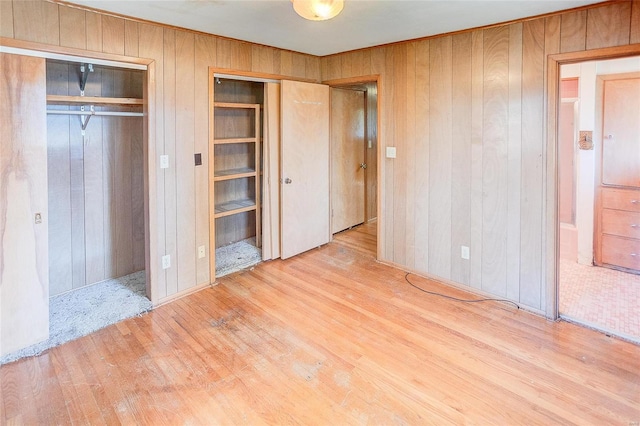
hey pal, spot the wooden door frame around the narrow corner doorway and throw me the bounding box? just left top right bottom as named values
left=322, top=74, right=384, bottom=259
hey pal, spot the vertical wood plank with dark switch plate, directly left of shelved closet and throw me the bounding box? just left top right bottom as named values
left=193, top=35, right=216, bottom=284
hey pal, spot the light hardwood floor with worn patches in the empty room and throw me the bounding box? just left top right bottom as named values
left=0, top=221, right=640, bottom=425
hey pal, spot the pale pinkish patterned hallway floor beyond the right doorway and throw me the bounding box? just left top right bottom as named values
left=560, top=259, right=640, bottom=342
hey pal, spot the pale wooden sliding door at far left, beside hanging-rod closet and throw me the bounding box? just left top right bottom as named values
left=0, top=53, right=49, bottom=356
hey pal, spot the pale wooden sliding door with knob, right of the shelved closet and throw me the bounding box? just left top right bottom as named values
left=280, top=80, right=330, bottom=259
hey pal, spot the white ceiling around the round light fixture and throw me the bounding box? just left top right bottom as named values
left=63, top=0, right=601, bottom=56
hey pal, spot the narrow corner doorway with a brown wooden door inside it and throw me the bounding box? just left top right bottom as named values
left=331, top=81, right=378, bottom=251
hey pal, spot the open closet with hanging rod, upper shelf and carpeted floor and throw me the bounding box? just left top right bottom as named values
left=46, top=59, right=152, bottom=343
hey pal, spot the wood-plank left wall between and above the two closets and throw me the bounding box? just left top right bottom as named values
left=0, top=0, right=321, bottom=303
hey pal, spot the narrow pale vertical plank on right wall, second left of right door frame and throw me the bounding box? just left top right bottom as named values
left=507, top=23, right=522, bottom=300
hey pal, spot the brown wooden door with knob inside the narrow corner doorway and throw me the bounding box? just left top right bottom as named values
left=331, top=88, right=366, bottom=234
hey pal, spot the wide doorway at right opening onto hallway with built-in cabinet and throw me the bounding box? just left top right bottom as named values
left=556, top=56, right=640, bottom=342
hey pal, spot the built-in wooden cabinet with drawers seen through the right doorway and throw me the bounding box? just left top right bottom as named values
left=594, top=74, right=640, bottom=273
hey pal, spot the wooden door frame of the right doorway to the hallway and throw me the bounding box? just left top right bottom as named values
left=542, top=44, right=640, bottom=320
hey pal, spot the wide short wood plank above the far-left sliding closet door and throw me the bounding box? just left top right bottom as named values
left=13, top=1, right=60, bottom=45
